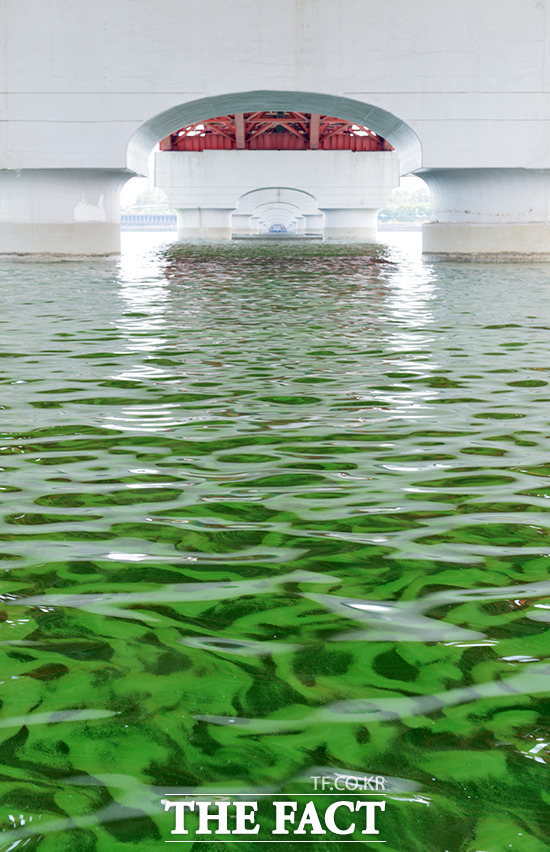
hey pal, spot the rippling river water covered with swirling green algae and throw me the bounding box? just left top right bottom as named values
left=0, top=234, right=550, bottom=852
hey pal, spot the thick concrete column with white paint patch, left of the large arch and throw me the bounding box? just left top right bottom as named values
left=0, top=169, right=132, bottom=257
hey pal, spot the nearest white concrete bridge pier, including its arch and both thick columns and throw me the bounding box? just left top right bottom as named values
left=0, top=0, right=550, bottom=260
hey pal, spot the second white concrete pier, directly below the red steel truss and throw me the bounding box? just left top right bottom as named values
left=155, top=150, right=399, bottom=240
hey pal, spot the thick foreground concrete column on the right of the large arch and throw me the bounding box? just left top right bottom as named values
left=419, top=169, right=550, bottom=261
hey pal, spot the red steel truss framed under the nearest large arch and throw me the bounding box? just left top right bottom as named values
left=160, top=111, right=393, bottom=151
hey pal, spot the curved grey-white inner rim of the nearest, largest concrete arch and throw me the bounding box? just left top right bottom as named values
left=127, top=89, right=422, bottom=175
